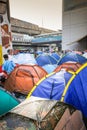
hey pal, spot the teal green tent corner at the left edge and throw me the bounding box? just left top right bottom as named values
left=0, top=86, right=20, bottom=116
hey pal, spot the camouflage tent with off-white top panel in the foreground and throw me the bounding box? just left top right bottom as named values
left=0, top=97, right=78, bottom=130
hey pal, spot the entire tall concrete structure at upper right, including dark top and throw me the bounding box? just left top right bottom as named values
left=62, top=0, right=87, bottom=50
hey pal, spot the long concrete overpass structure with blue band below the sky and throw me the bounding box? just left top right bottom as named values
left=11, top=17, right=62, bottom=50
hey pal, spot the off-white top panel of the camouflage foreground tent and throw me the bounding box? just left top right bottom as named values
left=10, top=96, right=57, bottom=121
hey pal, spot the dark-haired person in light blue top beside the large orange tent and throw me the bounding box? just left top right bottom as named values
left=2, top=54, right=16, bottom=74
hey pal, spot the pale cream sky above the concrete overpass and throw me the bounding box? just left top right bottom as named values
left=9, top=0, right=62, bottom=31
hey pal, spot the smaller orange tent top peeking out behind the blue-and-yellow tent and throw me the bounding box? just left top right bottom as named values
left=54, top=62, right=81, bottom=72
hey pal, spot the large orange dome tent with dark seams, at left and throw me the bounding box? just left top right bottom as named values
left=4, top=65, right=48, bottom=94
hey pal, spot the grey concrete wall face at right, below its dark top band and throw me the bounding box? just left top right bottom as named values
left=62, top=2, right=87, bottom=50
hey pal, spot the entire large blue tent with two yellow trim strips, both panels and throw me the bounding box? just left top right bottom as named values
left=28, top=63, right=87, bottom=118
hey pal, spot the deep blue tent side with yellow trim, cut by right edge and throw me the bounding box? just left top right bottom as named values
left=61, top=63, right=87, bottom=118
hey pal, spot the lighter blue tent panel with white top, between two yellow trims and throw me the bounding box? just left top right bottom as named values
left=28, top=70, right=72, bottom=100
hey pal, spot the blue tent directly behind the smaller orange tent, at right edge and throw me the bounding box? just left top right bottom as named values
left=58, top=52, right=87, bottom=65
